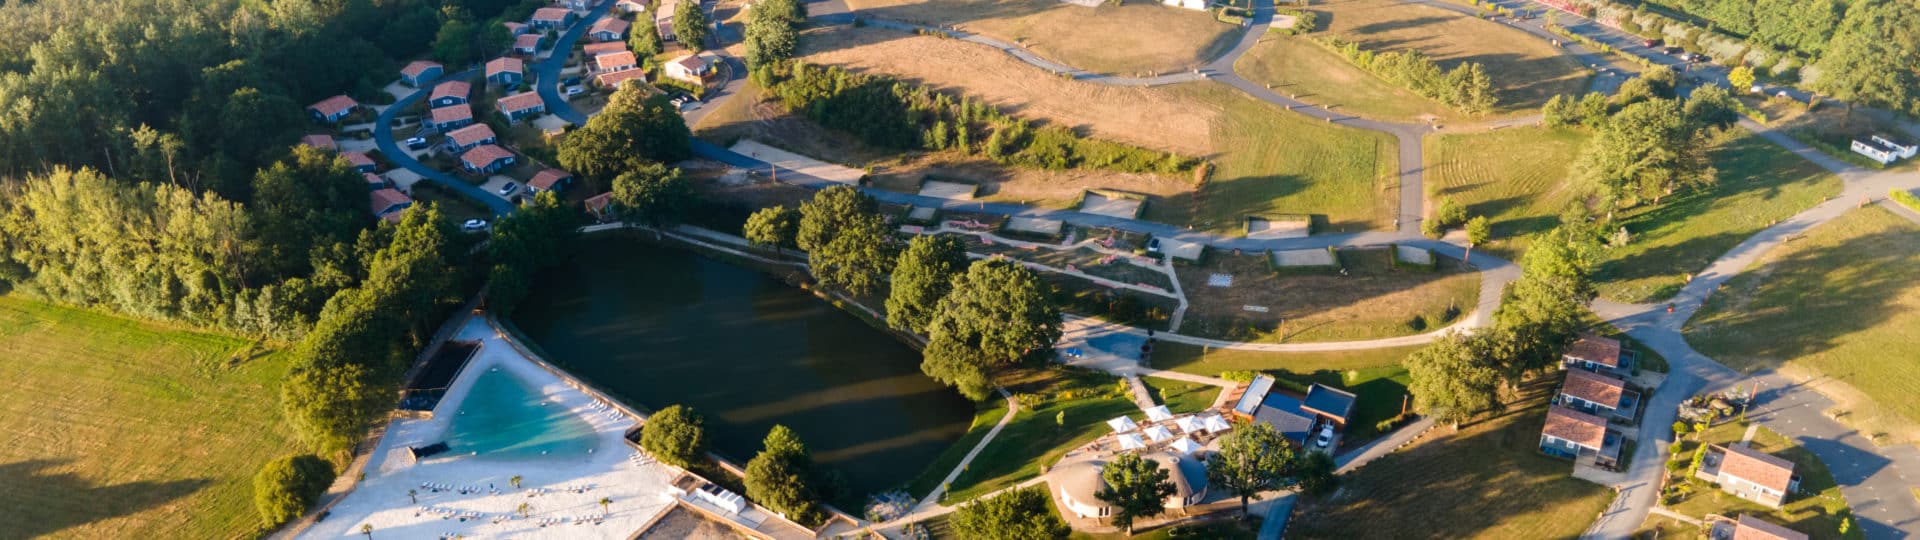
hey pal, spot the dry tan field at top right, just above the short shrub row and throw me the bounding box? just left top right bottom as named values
left=1290, top=0, right=1590, bottom=115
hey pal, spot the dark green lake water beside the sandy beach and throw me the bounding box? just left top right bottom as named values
left=513, top=234, right=973, bottom=499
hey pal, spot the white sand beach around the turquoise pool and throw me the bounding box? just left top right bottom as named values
left=300, top=317, right=680, bottom=538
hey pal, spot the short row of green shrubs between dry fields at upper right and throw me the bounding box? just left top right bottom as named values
left=1313, top=37, right=1500, bottom=113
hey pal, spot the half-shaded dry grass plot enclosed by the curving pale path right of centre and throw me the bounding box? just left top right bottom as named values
left=1179, top=250, right=1480, bottom=342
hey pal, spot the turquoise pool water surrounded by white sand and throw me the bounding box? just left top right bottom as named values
left=447, top=369, right=599, bottom=459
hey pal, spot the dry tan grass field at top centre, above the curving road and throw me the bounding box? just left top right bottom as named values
left=847, top=0, right=1240, bottom=75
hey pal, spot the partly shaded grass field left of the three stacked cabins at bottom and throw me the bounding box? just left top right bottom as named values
left=1286, top=382, right=1613, bottom=538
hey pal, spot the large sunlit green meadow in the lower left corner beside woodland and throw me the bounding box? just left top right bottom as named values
left=0, top=296, right=300, bottom=538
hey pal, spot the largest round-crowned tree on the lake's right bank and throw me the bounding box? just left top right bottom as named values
left=920, top=259, right=1060, bottom=400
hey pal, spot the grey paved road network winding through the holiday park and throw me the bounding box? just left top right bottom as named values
left=376, top=0, right=1920, bottom=538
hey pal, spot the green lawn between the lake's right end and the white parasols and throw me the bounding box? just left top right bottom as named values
left=947, top=367, right=1140, bottom=503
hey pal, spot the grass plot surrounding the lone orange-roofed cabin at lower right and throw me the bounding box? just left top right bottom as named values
left=1668, top=423, right=1864, bottom=538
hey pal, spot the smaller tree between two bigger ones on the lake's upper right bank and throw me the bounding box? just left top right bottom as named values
left=887, top=236, right=968, bottom=334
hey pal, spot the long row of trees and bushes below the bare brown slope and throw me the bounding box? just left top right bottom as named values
left=751, top=61, right=1198, bottom=173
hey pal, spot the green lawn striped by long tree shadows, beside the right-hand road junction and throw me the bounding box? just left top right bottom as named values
left=1596, top=129, right=1841, bottom=302
